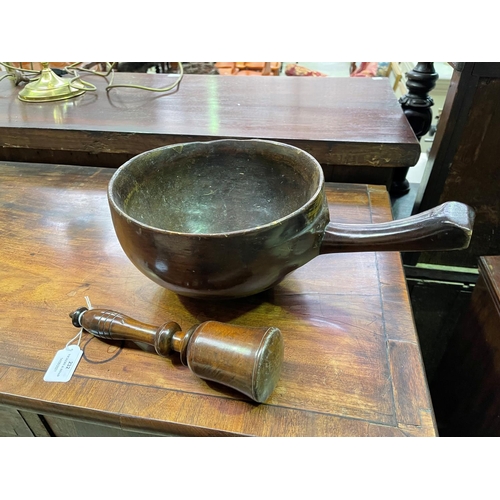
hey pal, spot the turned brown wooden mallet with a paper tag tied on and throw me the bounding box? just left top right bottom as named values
left=70, top=307, right=283, bottom=403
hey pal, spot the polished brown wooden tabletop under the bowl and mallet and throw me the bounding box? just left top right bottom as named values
left=0, top=162, right=436, bottom=436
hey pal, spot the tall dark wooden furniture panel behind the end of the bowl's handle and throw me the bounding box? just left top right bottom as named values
left=405, top=63, right=500, bottom=267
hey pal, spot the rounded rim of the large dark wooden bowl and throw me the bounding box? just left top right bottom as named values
left=107, top=138, right=325, bottom=238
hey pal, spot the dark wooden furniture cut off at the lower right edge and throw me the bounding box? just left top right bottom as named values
left=432, top=256, right=500, bottom=436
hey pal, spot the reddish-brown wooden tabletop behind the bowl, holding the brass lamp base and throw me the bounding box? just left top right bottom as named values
left=0, top=73, right=420, bottom=173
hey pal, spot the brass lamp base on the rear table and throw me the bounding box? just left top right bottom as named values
left=18, top=63, right=85, bottom=102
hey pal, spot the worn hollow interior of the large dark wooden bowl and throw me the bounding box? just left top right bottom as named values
left=110, top=141, right=323, bottom=234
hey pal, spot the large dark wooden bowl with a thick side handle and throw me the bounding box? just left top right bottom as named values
left=108, top=139, right=474, bottom=298
